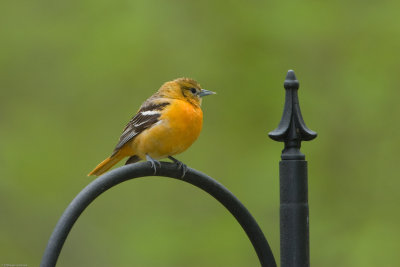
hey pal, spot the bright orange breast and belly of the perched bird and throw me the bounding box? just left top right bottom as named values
left=131, top=99, right=203, bottom=159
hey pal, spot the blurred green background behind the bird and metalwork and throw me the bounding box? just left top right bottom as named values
left=0, top=0, right=400, bottom=267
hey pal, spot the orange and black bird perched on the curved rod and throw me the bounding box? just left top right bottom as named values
left=88, top=78, right=215, bottom=177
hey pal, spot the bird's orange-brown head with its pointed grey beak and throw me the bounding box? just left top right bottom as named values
left=158, top=78, right=215, bottom=106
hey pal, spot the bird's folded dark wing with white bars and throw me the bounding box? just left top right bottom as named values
left=112, top=101, right=170, bottom=155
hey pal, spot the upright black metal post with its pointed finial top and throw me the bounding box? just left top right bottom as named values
left=269, top=70, right=317, bottom=267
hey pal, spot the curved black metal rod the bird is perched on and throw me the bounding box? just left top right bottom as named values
left=40, top=162, right=276, bottom=267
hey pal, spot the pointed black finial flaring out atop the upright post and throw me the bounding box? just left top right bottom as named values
left=268, top=70, right=317, bottom=160
